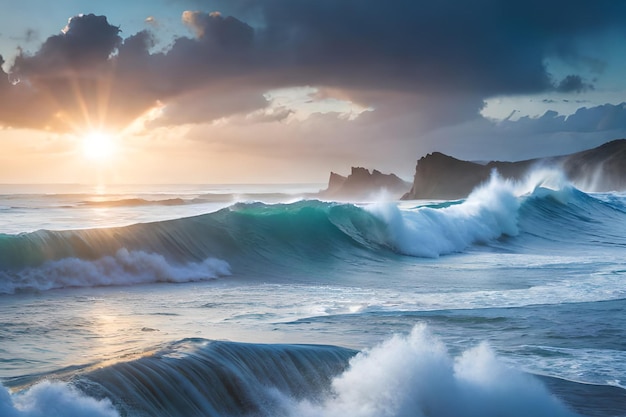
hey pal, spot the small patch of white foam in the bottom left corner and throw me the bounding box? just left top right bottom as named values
left=0, top=381, right=119, bottom=417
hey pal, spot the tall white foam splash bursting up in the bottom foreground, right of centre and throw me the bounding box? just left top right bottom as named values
left=286, top=325, right=577, bottom=417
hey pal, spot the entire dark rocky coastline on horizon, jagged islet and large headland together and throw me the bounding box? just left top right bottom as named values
left=311, top=139, right=626, bottom=201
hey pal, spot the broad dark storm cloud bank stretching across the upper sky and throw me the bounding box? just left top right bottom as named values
left=0, top=0, right=626, bottom=132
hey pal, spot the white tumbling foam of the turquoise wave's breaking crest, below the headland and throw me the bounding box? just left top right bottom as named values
left=369, top=172, right=520, bottom=257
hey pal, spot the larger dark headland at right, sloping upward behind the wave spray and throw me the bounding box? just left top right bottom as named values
left=401, top=139, right=626, bottom=200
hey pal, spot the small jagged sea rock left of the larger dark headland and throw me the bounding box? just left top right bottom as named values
left=319, top=167, right=411, bottom=200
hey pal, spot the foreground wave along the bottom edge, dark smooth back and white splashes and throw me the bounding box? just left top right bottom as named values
left=0, top=325, right=600, bottom=417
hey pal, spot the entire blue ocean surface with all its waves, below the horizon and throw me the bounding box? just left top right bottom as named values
left=0, top=171, right=626, bottom=417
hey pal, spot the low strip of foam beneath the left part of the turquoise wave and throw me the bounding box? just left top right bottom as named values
left=0, top=249, right=230, bottom=294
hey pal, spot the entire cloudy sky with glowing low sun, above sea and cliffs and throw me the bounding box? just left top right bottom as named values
left=0, top=0, right=626, bottom=184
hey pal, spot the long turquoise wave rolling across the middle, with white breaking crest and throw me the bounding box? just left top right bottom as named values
left=0, top=169, right=626, bottom=293
